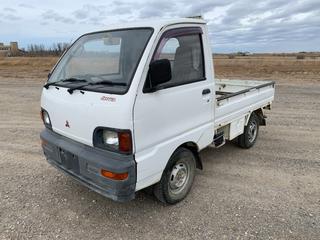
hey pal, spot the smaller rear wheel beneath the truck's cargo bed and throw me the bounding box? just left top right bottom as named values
left=238, top=113, right=259, bottom=148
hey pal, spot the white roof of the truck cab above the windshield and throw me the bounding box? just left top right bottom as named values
left=97, top=18, right=206, bottom=30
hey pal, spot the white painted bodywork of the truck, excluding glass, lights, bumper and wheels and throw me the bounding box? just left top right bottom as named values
left=41, top=19, right=274, bottom=194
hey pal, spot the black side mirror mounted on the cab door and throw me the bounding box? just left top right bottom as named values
left=148, top=59, right=172, bottom=91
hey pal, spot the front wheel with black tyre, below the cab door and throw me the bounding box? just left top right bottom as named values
left=154, top=148, right=196, bottom=204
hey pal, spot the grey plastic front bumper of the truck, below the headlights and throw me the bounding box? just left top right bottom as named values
left=40, top=129, right=137, bottom=202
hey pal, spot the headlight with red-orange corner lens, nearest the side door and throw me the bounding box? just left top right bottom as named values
left=93, top=127, right=132, bottom=154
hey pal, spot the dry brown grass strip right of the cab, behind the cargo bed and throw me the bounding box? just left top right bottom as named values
left=214, top=55, right=320, bottom=83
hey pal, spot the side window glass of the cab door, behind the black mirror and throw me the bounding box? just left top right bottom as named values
left=154, top=34, right=204, bottom=87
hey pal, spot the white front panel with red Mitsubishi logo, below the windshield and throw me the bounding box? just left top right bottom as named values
left=41, top=86, right=132, bottom=146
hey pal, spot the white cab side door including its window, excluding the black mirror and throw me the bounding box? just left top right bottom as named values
left=134, top=27, right=213, bottom=187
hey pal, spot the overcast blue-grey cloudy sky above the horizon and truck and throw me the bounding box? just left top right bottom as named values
left=0, top=0, right=320, bottom=52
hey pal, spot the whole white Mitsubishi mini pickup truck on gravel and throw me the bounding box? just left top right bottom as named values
left=41, top=18, right=275, bottom=204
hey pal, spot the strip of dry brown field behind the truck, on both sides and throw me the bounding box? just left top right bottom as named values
left=0, top=54, right=320, bottom=83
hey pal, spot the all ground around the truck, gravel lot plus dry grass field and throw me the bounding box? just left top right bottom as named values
left=0, top=57, right=320, bottom=239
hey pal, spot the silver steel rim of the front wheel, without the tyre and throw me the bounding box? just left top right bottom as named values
left=169, top=162, right=190, bottom=194
